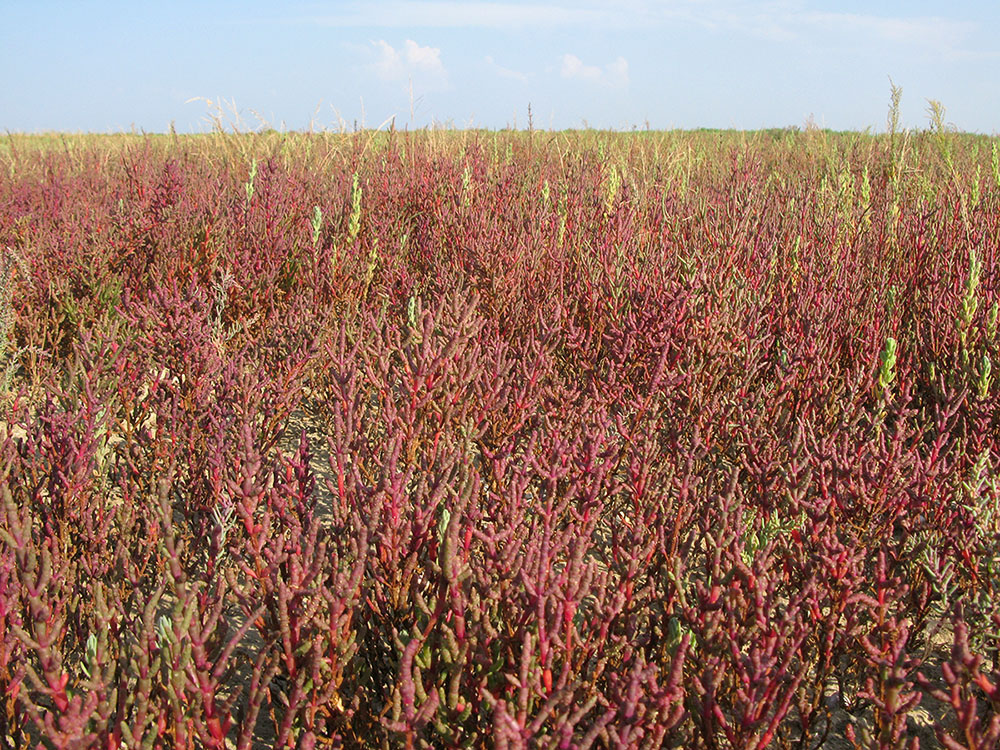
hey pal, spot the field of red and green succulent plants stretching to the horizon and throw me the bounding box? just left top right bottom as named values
left=0, top=128, right=1000, bottom=750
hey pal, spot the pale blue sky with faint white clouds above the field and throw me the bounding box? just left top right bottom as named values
left=0, top=0, right=1000, bottom=134
